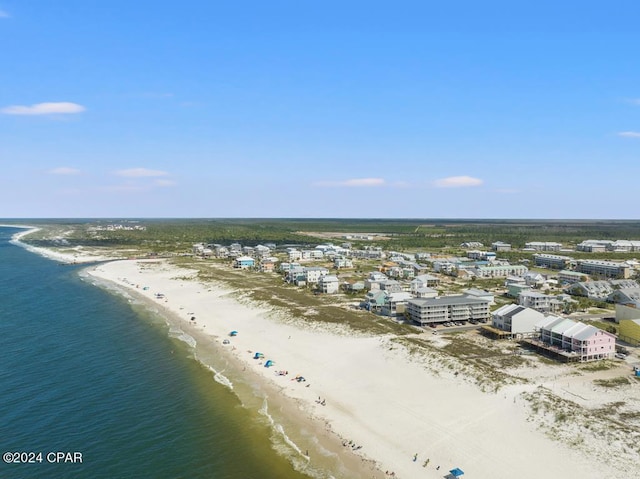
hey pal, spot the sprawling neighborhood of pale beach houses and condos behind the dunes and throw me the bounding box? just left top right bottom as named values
left=192, top=235, right=640, bottom=361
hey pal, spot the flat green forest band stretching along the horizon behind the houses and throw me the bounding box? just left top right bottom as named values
left=13, top=218, right=640, bottom=258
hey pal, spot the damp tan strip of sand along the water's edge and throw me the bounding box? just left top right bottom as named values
left=83, top=260, right=384, bottom=479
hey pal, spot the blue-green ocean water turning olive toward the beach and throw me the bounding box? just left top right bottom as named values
left=0, top=227, right=310, bottom=479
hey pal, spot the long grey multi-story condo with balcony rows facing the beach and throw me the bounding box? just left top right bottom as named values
left=406, top=296, right=489, bottom=326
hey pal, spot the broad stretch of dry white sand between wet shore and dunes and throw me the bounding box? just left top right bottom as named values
left=82, top=260, right=637, bottom=479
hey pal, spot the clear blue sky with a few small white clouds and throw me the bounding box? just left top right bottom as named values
left=0, top=0, right=640, bottom=219
